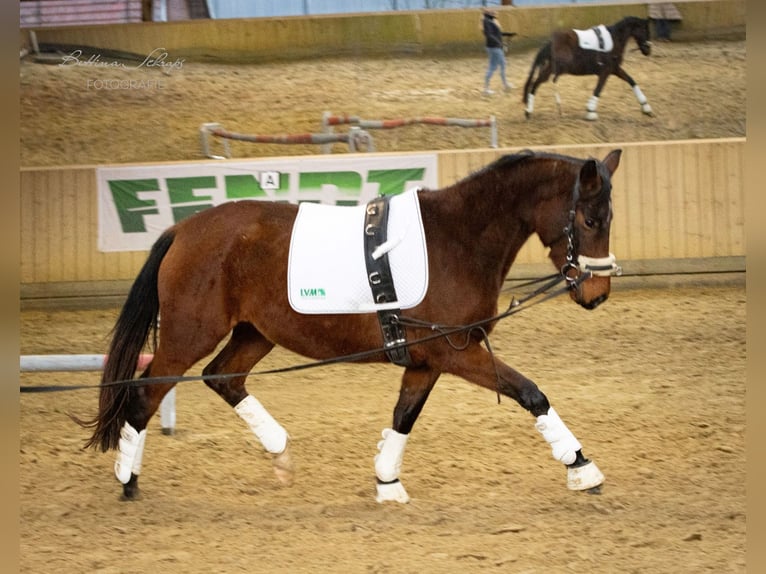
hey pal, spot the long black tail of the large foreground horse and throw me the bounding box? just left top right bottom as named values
left=72, top=231, right=174, bottom=452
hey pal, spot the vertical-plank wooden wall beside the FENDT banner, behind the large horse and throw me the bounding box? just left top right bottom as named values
left=20, top=138, right=745, bottom=306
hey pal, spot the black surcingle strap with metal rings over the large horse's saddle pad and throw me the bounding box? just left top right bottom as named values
left=364, top=196, right=411, bottom=367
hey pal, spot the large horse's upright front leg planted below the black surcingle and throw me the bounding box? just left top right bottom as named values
left=375, top=367, right=441, bottom=503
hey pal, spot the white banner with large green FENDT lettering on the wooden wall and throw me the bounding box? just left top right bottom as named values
left=96, top=154, right=437, bottom=251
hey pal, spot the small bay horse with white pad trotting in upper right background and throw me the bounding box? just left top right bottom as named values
left=522, top=16, right=653, bottom=120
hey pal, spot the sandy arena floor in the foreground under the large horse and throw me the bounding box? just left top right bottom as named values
left=20, top=279, right=746, bottom=574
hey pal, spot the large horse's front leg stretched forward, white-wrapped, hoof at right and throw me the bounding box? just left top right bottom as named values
left=449, top=345, right=604, bottom=498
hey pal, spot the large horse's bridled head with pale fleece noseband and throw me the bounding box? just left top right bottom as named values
left=550, top=149, right=622, bottom=309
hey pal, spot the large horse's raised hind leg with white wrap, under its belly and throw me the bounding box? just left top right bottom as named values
left=202, top=323, right=293, bottom=483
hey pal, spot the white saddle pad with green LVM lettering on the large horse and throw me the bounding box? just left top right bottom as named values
left=287, top=189, right=428, bottom=314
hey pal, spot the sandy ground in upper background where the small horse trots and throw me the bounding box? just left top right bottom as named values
left=20, top=39, right=746, bottom=166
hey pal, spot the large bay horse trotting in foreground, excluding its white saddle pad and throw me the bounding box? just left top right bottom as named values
left=73, top=149, right=622, bottom=502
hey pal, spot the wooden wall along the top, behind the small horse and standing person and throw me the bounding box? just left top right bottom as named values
left=20, top=0, right=747, bottom=62
